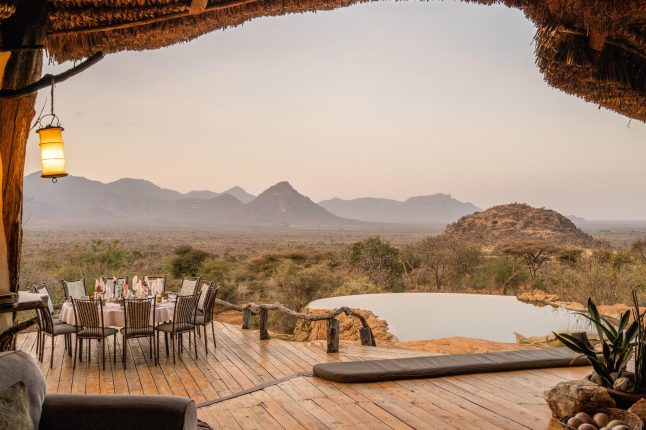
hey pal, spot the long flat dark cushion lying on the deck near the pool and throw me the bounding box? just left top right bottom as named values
left=314, top=348, right=590, bottom=382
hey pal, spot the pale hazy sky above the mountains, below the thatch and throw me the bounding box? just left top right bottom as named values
left=26, top=2, right=646, bottom=219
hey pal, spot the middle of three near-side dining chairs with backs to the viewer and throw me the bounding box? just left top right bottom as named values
left=121, top=297, right=157, bottom=369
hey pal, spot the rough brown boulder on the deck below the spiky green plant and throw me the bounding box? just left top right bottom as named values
left=545, top=380, right=616, bottom=418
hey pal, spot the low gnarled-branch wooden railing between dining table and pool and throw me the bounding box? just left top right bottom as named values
left=215, top=299, right=376, bottom=353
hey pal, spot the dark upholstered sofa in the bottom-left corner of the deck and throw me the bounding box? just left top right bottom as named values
left=0, top=351, right=197, bottom=430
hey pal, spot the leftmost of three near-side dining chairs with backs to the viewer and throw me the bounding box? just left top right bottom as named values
left=72, top=299, right=118, bottom=370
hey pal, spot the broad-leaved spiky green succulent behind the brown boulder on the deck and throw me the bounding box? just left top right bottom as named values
left=554, top=299, right=646, bottom=388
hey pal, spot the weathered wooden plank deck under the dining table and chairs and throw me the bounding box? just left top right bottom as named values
left=18, top=323, right=589, bottom=430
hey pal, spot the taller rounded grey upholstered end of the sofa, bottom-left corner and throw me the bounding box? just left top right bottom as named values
left=0, top=351, right=47, bottom=429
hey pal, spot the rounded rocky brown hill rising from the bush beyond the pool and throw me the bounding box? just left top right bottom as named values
left=445, top=203, right=593, bottom=247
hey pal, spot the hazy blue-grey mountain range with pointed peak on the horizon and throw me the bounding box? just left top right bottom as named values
left=23, top=172, right=478, bottom=226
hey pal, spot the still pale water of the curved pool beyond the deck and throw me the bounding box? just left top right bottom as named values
left=308, top=293, right=590, bottom=342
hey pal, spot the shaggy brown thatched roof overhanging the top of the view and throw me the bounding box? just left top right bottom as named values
left=0, top=0, right=646, bottom=122
